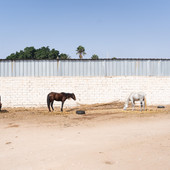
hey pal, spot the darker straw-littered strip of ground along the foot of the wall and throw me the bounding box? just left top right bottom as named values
left=0, top=102, right=170, bottom=126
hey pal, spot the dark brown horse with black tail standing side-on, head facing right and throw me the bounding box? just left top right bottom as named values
left=47, top=92, right=76, bottom=112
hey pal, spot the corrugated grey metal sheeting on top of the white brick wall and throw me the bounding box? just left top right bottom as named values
left=0, top=59, right=170, bottom=77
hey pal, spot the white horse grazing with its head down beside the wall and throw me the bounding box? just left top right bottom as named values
left=123, top=92, right=146, bottom=111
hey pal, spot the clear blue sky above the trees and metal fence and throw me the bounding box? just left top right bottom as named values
left=0, top=0, right=170, bottom=59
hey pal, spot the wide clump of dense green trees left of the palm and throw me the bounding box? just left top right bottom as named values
left=6, top=46, right=70, bottom=60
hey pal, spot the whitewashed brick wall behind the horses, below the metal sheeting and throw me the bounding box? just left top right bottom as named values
left=0, top=76, right=170, bottom=107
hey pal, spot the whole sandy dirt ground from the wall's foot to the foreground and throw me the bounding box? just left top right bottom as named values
left=0, top=102, right=170, bottom=170
